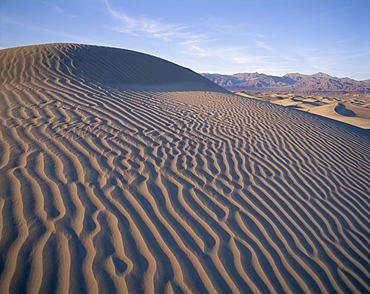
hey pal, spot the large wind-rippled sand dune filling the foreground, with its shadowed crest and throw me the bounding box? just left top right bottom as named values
left=0, top=44, right=370, bottom=293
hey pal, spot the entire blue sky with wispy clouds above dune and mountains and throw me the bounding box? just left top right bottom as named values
left=0, top=0, right=370, bottom=80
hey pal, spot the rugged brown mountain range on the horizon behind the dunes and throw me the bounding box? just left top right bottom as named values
left=201, top=72, right=370, bottom=96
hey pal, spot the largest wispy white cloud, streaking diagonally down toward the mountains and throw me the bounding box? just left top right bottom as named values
left=101, top=0, right=304, bottom=76
